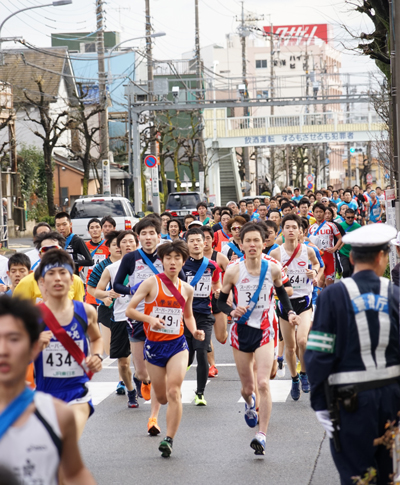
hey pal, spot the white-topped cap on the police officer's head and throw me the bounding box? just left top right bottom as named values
left=342, top=224, right=397, bottom=251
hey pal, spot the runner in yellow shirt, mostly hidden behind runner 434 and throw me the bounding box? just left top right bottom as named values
left=13, top=232, right=85, bottom=303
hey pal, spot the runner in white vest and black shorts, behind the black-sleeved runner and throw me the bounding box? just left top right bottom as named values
left=94, top=231, right=139, bottom=408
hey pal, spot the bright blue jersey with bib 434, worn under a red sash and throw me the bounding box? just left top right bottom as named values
left=35, top=300, right=89, bottom=401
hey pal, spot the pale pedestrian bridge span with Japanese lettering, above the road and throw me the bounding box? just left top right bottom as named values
left=203, top=108, right=387, bottom=148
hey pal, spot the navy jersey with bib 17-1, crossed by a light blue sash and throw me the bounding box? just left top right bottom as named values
left=182, top=258, right=218, bottom=315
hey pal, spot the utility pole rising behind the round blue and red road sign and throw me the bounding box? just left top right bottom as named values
left=146, top=0, right=161, bottom=214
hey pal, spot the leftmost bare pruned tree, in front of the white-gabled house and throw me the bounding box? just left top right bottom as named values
left=24, top=78, right=71, bottom=215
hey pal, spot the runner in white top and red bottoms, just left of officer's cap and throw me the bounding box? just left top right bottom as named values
left=308, top=202, right=342, bottom=286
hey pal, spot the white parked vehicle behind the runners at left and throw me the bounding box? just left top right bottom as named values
left=70, top=195, right=139, bottom=240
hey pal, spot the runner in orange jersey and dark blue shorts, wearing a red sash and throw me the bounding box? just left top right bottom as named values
left=127, top=240, right=205, bottom=458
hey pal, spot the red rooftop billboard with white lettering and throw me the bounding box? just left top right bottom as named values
left=264, top=24, right=331, bottom=45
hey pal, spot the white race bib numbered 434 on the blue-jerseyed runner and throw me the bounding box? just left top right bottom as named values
left=42, top=340, right=83, bottom=379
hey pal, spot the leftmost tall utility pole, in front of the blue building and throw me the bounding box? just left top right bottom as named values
left=96, top=0, right=110, bottom=193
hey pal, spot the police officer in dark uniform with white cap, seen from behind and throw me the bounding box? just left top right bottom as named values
left=305, top=224, right=400, bottom=485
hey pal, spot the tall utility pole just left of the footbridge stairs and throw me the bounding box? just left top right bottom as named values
left=194, top=0, right=204, bottom=194
